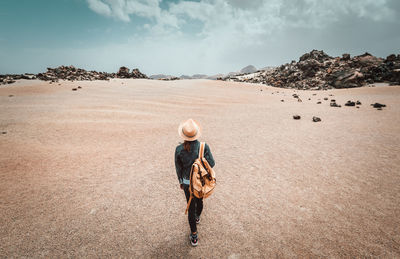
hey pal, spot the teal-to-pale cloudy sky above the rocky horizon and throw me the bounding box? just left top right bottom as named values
left=0, top=0, right=400, bottom=76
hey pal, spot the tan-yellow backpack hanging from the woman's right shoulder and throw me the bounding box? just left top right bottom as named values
left=185, top=142, right=217, bottom=214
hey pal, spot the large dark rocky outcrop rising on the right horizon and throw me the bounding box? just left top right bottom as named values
left=224, top=50, right=400, bottom=90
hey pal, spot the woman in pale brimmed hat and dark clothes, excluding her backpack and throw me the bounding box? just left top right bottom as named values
left=175, top=119, right=215, bottom=246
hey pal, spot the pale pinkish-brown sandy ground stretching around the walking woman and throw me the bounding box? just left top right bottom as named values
left=0, top=80, right=400, bottom=258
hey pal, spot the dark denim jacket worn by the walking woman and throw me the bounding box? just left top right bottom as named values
left=175, top=140, right=215, bottom=185
